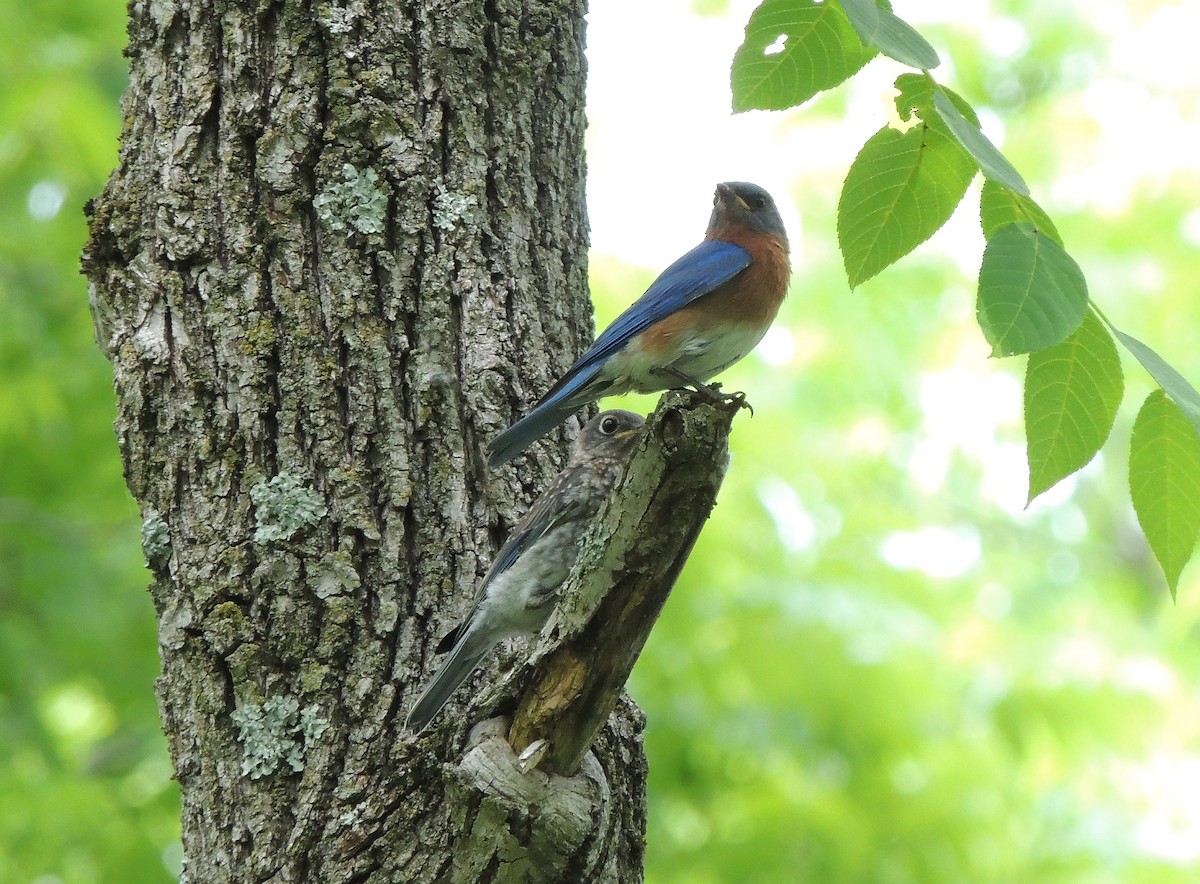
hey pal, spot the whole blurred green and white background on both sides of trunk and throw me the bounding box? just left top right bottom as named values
left=0, top=0, right=1200, bottom=884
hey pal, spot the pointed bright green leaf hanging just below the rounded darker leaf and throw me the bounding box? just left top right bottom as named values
left=1025, top=313, right=1124, bottom=503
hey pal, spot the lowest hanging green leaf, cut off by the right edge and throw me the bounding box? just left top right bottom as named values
left=1129, top=390, right=1200, bottom=599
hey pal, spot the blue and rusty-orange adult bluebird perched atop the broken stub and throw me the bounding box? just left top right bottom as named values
left=487, top=181, right=791, bottom=467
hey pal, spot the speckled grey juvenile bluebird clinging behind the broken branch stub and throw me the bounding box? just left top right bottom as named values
left=406, top=410, right=646, bottom=732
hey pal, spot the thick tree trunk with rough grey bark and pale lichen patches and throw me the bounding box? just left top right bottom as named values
left=84, top=0, right=667, bottom=884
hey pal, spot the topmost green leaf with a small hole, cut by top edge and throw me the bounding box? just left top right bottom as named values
left=730, top=0, right=875, bottom=113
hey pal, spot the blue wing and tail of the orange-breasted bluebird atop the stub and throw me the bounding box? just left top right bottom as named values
left=487, top=240, right=750, bottom=467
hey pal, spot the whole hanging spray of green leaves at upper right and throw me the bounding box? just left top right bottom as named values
left=730, top=0, right=1200, bottom=599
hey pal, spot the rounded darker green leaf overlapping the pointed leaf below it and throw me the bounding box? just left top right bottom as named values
left=976, top=221, right=1087, bottom=356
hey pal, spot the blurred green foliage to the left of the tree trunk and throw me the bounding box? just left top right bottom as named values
left=0, top=0, right=179, bottom=884
